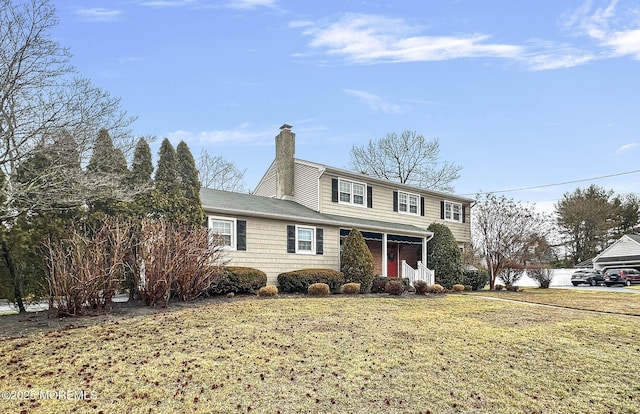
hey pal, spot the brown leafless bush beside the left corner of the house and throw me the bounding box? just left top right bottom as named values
left=137, top=220, right=225, bottom=306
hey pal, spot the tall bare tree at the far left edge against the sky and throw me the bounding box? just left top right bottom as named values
left=0, top=0, right=134, bottom=219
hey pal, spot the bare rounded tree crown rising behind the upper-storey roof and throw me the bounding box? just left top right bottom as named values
left=350, top=131, right=462, bottom=192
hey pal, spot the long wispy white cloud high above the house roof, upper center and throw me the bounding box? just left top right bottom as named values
left=298, top=14, right=523, bottom=63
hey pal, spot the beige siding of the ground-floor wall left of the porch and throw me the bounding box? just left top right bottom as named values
left=211, top=213, right=340, bottom=285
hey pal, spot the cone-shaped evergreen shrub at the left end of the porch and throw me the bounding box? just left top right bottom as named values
left=340, top=229, right=374, bottom=293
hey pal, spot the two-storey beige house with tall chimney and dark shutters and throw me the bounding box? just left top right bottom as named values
left=201, top=125, right=474, bottom=284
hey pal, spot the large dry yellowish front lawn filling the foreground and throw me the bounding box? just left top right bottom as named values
left=0, top=294, right=640, bottom=413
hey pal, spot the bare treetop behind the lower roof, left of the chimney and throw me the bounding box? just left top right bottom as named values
left=198, top=149, right=247, bottom=192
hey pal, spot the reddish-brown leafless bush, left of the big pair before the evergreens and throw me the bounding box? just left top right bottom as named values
left=44, top=218, right=132, bottom=315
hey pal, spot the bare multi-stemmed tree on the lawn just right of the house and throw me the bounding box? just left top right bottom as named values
left=472, top=194, right=550, bottom=289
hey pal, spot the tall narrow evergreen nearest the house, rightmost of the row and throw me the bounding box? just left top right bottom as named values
left=176, top=141, right=205, bottom=225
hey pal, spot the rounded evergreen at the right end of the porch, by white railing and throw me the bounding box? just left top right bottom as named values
left=427, top=223, right=464, bottom=289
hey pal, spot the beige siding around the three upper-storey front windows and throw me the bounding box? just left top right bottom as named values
left=320, top=174, right=471, bottom=243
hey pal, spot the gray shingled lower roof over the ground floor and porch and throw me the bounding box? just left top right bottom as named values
left=200, top=188, right=430, bottom=236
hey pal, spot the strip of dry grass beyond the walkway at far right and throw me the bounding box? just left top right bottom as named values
left=471, top=288, right=640, bottom=316
